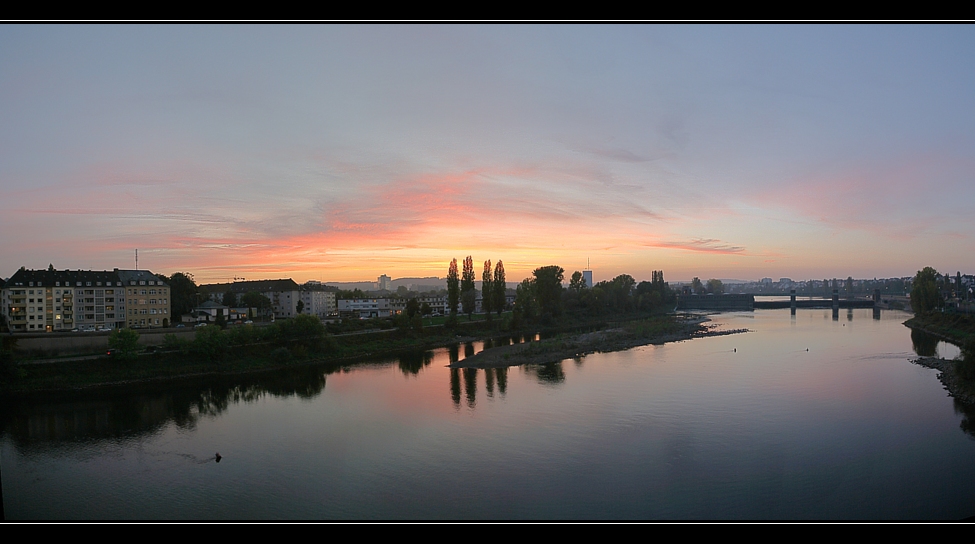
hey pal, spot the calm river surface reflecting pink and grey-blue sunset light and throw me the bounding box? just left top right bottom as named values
left=0, top=309, right=975, bottom=519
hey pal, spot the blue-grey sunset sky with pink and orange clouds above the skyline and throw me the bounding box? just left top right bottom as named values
left=0, top=25, right=975, bottom=283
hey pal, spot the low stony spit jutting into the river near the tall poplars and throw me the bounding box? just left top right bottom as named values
left=450, top=315, right=748, bottom=368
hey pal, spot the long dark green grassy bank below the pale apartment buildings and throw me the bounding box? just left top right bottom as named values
left=0, top=313, right=677, bottom=392
